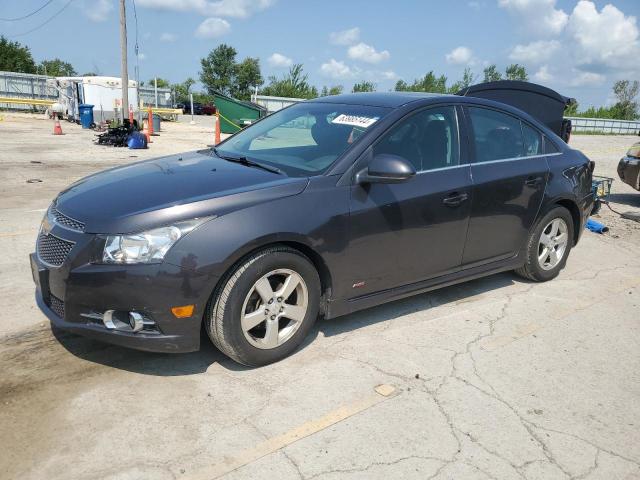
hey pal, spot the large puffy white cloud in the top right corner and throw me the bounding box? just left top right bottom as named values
left=569, top=0, right=640, bottom=71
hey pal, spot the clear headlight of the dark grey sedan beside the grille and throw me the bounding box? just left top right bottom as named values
left=102, top=217, right=210, bottom=264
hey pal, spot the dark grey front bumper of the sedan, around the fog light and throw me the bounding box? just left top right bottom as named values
left=30, top=238, right=216, bottom=353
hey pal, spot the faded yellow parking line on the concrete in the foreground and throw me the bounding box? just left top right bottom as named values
left=183, top=385, right=397, bottom=480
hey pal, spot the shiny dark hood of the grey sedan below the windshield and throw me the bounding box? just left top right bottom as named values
left=56, top=150, right=308, bottom=233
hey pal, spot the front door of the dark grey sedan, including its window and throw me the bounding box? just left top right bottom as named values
left=349, top=106, right=471, bottom=297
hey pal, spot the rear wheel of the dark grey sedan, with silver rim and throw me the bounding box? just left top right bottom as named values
left=515, top=206, right=574, bottom=282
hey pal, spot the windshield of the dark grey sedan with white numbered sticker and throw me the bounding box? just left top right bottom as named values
left=217, top=102, right=390, bottom=177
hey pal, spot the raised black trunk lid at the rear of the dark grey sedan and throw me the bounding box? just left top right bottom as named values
left=457, top=80, right=575, bottom=142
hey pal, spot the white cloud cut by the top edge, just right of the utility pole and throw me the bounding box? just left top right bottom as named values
left=138, top=0, right=275, bottom=18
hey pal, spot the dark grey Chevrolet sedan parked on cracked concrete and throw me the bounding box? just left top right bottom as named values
left=31, top=93, right=594, bottom=366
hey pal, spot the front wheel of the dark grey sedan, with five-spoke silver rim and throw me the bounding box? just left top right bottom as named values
left=204, top=246, right=321, bottom=367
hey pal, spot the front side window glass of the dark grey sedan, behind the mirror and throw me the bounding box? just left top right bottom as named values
left=373, top=106, right=460, bottom=172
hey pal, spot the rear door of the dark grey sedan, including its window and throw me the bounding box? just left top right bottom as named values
left=462, top=106, right=549, bottom=267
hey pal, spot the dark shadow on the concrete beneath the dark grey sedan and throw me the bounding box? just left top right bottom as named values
left=52, top=273, right=526, bottom=376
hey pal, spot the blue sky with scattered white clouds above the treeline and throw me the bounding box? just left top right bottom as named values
left=0, top=0, right=640, bottom=108
